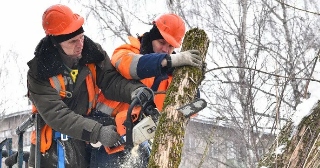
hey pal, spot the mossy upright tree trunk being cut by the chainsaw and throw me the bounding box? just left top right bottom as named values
left=149, top=28, right=209, bottom=168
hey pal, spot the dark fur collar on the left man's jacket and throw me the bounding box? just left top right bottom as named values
left=28, top=36, right=105, bottom=80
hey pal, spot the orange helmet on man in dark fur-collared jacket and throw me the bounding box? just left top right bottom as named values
left=42, top=4, right=84, bottom=36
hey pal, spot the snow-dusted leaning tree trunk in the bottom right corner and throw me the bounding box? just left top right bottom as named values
left=259, top=102, right=320, bottom=168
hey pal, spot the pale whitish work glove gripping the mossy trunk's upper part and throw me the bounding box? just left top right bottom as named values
left=170, top=50, right=202, bottom=67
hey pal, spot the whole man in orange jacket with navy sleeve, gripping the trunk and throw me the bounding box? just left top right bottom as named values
left=91, top=13, right=203, bottom=167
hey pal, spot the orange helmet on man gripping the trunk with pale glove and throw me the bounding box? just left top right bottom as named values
left=154, top=14, right=186, bottom=48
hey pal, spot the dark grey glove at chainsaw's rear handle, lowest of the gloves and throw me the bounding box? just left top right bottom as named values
left=97, top=125, right=121, bottom=147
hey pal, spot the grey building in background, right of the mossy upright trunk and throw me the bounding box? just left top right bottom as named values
left=180, top=119, right=275, bottom=168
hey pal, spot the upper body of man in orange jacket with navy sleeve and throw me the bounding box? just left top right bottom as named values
left=111, top=13, right=203, bottom=111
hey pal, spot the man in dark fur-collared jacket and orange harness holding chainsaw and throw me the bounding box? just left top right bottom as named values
left=27, top=4, right=150, bottom=168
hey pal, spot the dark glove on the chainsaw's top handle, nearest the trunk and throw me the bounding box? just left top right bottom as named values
left=131, top=87, right=154, bottom=107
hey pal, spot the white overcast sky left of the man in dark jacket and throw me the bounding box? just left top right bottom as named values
left=0, top=0, right=60, bottom=114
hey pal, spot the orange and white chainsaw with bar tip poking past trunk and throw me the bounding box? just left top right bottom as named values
left=92, top=89, right=207, bottom=154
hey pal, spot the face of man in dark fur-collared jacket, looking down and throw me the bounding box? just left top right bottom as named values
left=60, top=33, right=84, bottom=57
